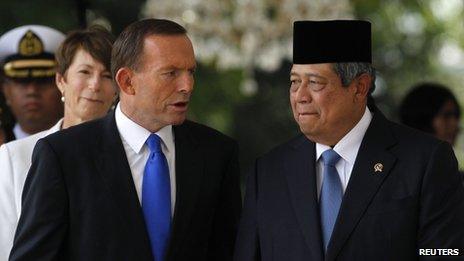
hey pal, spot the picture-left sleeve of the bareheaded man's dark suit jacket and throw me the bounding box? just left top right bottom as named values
left=9, top=139, right=68, bottom=261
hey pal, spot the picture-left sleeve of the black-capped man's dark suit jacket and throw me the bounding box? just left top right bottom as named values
left=234, top=157, right=261, bottom=261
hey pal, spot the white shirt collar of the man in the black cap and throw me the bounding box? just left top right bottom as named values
left=316, top=106, right=372, bottom=162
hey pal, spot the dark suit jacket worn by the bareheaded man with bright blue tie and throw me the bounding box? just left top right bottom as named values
left=10, top=110, right=241, bottom=261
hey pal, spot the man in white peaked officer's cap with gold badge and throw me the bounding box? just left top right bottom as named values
left=0, top=25, right=65, bottom=140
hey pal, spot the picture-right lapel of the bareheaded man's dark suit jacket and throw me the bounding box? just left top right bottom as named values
left=168, top=122, right=205, bottom=253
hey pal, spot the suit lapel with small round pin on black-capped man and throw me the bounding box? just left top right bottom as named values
left=326, top=111, right=396, bottom=260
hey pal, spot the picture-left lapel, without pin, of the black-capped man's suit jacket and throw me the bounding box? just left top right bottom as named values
left=283, top=136, right=323, bottom=260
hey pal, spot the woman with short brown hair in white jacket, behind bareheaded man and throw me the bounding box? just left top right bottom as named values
left=0, top=24, right=117, bottom=260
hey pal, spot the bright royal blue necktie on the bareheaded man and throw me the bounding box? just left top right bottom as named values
left=142, top=134, right=171, bottom=261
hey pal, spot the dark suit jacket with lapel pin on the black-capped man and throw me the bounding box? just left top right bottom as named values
left=235, top=108, right=464, bottom=261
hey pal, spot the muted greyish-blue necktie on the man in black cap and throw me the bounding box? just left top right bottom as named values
left=319, top=149, right=343, bottom=250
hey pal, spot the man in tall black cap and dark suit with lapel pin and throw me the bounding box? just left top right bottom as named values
left=235, top=21, right=464, bottom=261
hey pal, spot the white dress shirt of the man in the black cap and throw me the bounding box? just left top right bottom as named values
left=316, top=107, right=372, bottom=198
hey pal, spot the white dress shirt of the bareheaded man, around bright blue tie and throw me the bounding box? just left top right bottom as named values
left=115, top=104, right=176, bottom=216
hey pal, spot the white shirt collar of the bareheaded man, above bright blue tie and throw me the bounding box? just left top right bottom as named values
left=115, top=103, right=174, bottom=154
